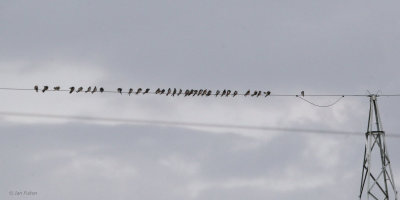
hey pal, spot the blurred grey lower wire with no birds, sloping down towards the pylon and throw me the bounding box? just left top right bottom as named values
left=0, top=112, right=400, bottom=138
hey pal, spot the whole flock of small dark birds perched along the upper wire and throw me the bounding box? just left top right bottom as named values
left=34, top=85, right=304, bottom=97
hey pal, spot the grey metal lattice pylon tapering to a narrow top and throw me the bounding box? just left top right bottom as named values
left=359, top=95, right=398, bottom=200
